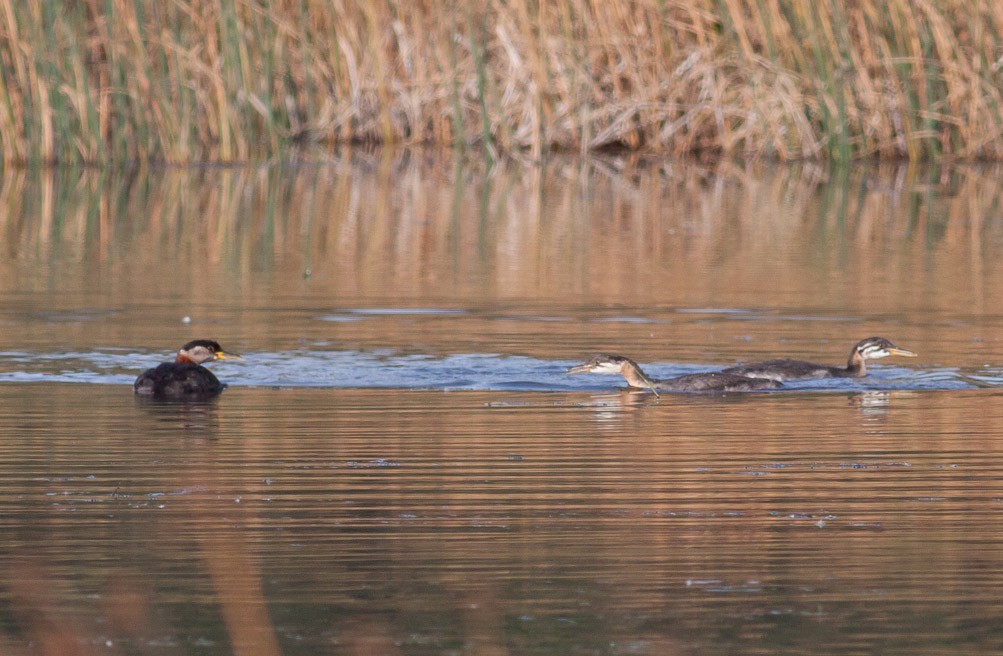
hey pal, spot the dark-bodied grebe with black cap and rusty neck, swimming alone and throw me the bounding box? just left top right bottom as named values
left=132, top=339, right=241, bottom=399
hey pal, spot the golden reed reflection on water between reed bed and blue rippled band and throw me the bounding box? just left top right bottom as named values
left=0, top=154, right=1003, bottom=366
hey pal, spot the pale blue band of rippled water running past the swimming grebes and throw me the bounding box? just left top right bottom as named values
left=0, top=349, right=986, bottom=391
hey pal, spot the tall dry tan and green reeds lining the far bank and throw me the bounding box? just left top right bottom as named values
left=0, top=0, right=1003, bottom=163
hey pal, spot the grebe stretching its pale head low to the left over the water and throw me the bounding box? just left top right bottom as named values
left=568, top=353, right=782, bottom=394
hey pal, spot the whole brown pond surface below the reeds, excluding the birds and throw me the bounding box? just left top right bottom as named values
left=0, top=154, right=1003, bottom=654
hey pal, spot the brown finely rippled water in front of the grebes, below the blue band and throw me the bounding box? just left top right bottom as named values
left=0, top=384, right=1003, bottom=654
